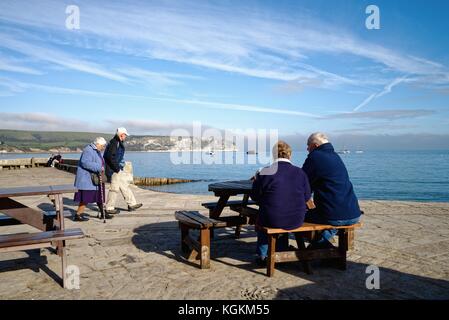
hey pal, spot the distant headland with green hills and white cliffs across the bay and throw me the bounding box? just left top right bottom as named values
left=0, top=130, right=235, bottom=153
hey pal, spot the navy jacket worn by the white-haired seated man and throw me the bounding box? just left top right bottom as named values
left=302, top=143, right=360, bottom=220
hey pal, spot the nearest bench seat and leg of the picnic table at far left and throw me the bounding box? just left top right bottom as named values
left=0, top=228, right=84, bottom=287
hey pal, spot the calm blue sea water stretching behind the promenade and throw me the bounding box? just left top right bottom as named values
left=0, top=150, right=449, bottom=202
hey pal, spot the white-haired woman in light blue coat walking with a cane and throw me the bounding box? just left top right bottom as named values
left=73, top=137, right=112, bottom=221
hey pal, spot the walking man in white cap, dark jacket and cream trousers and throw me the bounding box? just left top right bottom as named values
left=104, top=128, right=142, bottom=214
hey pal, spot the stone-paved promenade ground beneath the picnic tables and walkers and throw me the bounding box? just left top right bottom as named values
left=0, top=168, right=449, bottom=299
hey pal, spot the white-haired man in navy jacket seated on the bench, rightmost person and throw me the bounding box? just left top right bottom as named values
left=302, top=132, right=361, bottom=248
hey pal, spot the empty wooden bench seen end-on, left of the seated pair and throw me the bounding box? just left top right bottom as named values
left=175, top=211, right=229, bottom=269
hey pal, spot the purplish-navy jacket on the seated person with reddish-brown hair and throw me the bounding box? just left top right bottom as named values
left=251, top=161, right=311, bottom=230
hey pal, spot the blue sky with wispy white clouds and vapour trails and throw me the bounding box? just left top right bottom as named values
left=0, top=0, right=449, bottom=135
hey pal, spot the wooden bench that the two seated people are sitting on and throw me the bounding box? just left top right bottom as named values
left=264, top=223, right=361, bottom=277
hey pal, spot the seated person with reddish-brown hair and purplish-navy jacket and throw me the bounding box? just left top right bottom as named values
left=251, top=141, right=311, bottom=265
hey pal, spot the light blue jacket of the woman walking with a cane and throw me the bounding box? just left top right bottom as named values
left=75, top=143, right=103, bottom=190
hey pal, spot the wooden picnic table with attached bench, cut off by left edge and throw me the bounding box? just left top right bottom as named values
left=0, top=185, right=83, bottom=287
